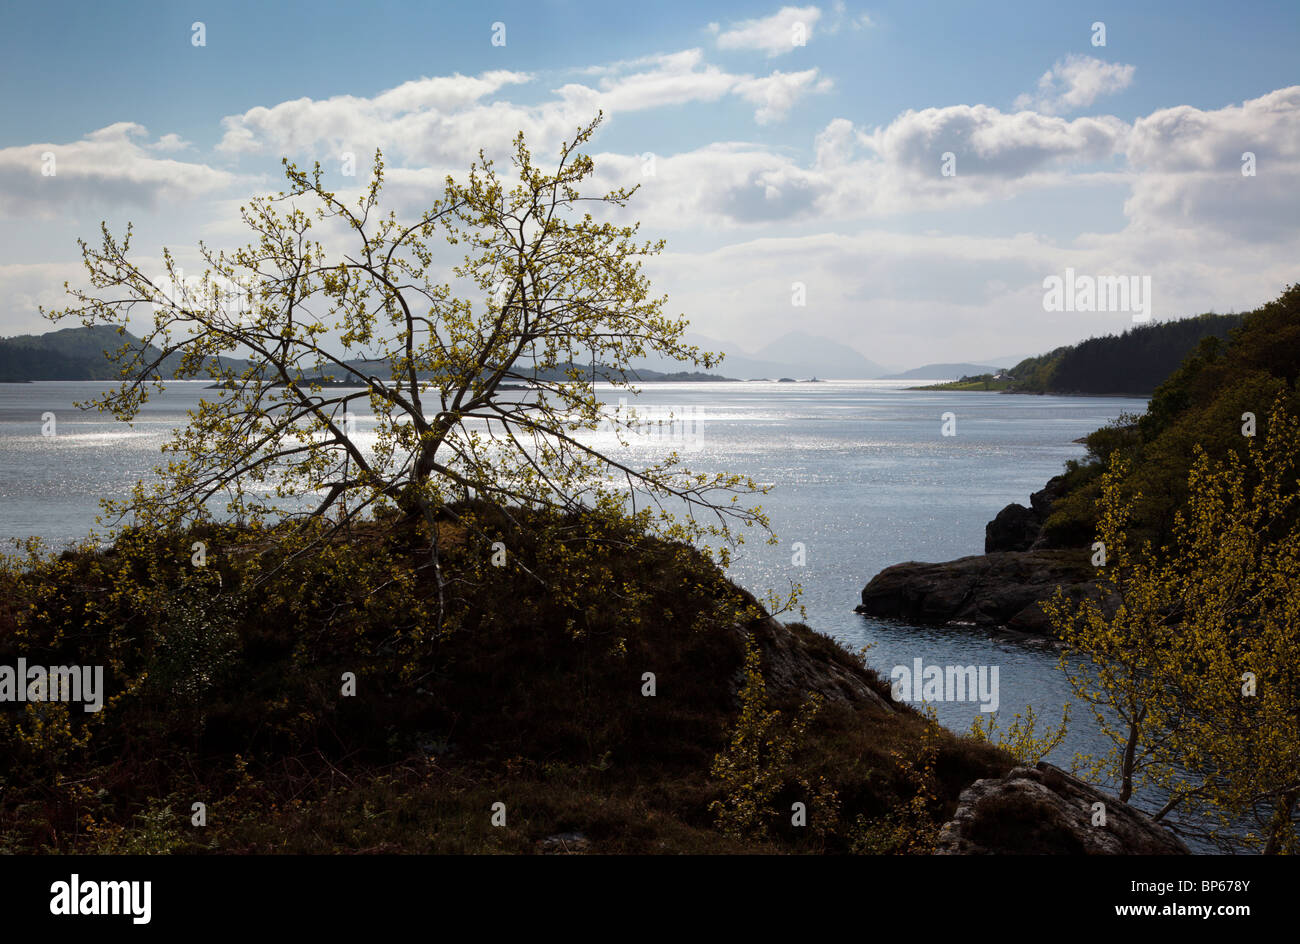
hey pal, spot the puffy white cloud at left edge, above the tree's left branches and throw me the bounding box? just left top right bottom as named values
left=0, top=121, right=237, bottom=216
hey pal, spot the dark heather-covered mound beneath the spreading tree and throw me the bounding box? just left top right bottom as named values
left=0, top=507, right=1011, bottom=853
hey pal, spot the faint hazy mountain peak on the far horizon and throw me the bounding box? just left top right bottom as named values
left=638, top=332, right=887, bottom=380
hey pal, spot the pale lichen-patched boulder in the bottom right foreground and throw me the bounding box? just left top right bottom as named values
left=935, top=763, right=1190, bottom=856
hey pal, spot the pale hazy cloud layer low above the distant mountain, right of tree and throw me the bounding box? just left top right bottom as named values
left=647, top=222, right=1295, bottom=374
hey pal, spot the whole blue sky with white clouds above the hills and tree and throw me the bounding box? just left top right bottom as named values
left=0, top=0, right=1300, bottom=368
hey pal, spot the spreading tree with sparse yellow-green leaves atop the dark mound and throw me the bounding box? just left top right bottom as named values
left=48, top=116, right=766, bottom=598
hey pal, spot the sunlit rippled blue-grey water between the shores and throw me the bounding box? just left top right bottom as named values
left=0, top=381, right=1227, bottom=852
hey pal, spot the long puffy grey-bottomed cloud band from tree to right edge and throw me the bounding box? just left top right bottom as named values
left=597, top=87, right=1300, bottom=248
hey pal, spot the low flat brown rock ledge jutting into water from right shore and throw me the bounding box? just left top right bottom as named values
left=857, top=550, right=1097, bottom=635
